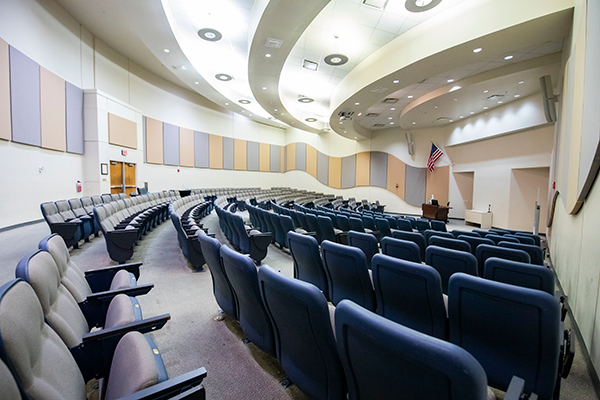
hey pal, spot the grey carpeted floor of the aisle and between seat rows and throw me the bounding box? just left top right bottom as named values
left=0, top=213, right=598, bottom=400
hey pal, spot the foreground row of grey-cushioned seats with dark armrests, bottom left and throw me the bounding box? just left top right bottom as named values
left=0, top=234, right=206, bottom=400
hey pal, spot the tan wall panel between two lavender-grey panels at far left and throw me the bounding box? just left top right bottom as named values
left=40, top=67, right=67, bottom=151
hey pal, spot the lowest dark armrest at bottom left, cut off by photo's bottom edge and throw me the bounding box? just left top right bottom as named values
left=120, top=368, right=206, bottom=400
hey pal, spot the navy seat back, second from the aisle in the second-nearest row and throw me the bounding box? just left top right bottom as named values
left=321, top=240, right=375, bottom=310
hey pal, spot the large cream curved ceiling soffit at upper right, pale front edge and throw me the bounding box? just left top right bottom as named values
left=330, top=0, right=573, bottom=137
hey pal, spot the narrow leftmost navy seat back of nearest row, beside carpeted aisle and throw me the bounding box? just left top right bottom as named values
left=196, top=229, right=238, bottom=319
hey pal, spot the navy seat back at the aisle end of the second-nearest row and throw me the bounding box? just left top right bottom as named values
left=287, top=232, right=329, bottom=298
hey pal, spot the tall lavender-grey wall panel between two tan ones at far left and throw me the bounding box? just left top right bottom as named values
left=9, top=46, right=42, bottom=146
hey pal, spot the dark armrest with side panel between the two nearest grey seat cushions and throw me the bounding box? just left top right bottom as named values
left=69, top=314, right=171, bottom=381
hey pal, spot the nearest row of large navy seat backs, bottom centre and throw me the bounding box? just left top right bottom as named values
left=198, top=233, right=544, bottom=400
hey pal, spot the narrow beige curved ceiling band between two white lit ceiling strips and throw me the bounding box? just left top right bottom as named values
left=248, top=0, right=330, bottom=133
